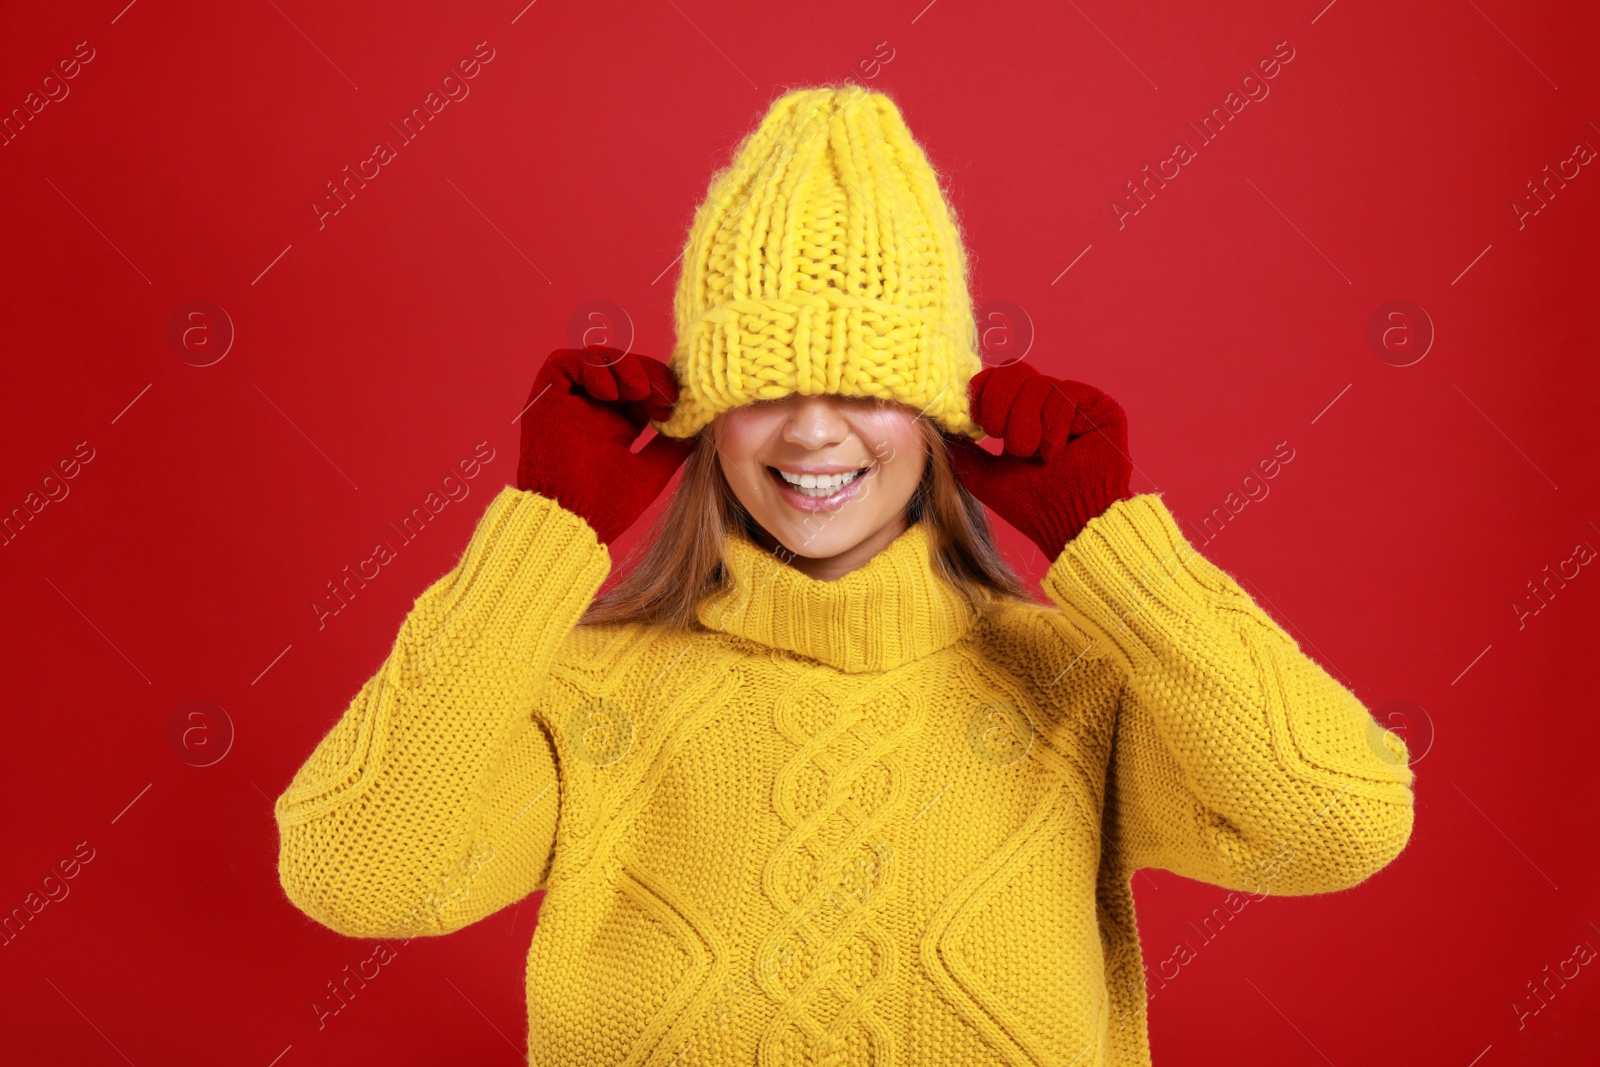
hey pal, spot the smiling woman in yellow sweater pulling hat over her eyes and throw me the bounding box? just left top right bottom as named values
left=277, top=86, right=1413, bottom=1067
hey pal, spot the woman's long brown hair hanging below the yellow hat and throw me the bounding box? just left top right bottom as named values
left=578, top=416, right=1037, bottom=627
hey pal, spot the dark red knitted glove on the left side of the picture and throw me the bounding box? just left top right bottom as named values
left=517, top=347, right=694, bottom=544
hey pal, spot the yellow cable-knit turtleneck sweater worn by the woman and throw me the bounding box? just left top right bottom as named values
left=275, top=486, right=1413, bottom=1067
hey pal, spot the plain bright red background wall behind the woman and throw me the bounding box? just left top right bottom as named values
left=0, top=0, right=1600, bottom=1067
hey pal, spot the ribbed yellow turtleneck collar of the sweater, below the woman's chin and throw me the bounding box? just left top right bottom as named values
left=699, top=523, right=976, bottom=673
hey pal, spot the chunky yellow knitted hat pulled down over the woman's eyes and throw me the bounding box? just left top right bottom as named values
left=654, top=85, right=984, bottom=438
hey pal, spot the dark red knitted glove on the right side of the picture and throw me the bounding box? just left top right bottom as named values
left=946, top=363, right=1133, bottom=560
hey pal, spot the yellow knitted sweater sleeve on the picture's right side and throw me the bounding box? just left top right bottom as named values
left=1043, top=493, right=1413, bottom=896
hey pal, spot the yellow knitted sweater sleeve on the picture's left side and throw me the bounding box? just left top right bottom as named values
left=274, top=486, right=611, bottom=937
